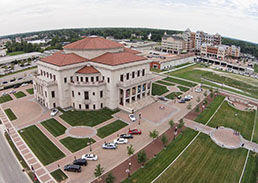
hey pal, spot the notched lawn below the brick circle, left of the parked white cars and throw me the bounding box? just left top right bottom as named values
left=60, top=137, right=96, bottom=153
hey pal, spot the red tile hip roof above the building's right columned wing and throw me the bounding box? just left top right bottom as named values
left=91, top=52, right=147, bottom=66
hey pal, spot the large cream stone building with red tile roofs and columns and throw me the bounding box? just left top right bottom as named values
left=33, top=36, right=153, bottom=111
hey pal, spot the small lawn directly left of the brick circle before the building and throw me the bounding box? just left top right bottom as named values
left=41, top=118, right=66, bottom=137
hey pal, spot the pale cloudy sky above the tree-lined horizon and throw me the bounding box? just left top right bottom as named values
left=0, top=0, right=258, bottom=43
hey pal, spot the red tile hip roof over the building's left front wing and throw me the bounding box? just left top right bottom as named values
left=40, top=52, right=88, bottom=66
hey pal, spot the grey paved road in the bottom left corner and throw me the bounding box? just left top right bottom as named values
left=0, top=129, right=31, bottom=183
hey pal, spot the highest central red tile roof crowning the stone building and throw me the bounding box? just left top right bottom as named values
left=64, top=36, right=124, bottom=50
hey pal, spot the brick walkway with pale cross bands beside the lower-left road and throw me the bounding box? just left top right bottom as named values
left=0, top=106, right=56, bottom=183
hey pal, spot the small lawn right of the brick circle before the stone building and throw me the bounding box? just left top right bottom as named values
left=97, top=120, right=128, bottom=138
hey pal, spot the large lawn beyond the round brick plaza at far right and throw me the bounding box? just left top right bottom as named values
left=209, top=102, right=255, bottom=140
